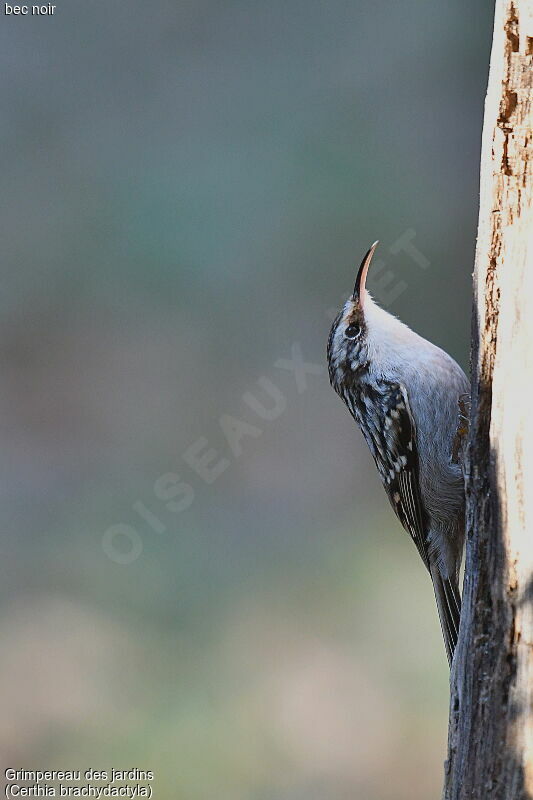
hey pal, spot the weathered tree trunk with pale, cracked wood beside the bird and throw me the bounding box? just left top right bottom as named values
left=443, top=0, right=533, bottom=800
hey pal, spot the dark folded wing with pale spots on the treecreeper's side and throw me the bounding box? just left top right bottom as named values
left=361, top=381, right=429, bottom=569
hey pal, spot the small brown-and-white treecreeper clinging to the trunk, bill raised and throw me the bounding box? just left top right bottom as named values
left=327, top=242, right=469, bottom=667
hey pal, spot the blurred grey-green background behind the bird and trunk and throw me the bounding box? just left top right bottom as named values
left=0, top=0, right=492, bottom=800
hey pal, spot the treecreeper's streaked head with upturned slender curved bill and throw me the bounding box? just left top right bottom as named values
left=328, top=242, right=378, bottom=391
